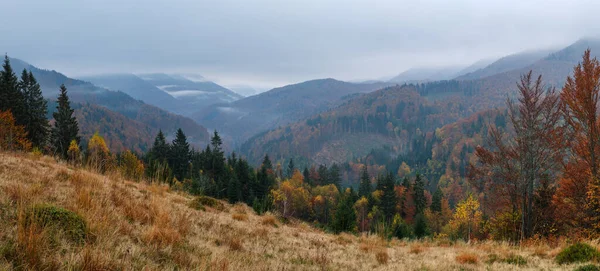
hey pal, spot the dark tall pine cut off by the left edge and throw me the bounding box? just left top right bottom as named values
left=0, top=55, right=26, bottom=126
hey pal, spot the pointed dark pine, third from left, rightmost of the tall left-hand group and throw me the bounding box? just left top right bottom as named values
left=52, top=85, right=80, bottom=159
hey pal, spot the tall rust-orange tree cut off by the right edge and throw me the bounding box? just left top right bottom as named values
left=554, top=49, right=600, bottom=234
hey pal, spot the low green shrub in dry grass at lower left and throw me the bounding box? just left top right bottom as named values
left=27, top=205, right=87, bottom=243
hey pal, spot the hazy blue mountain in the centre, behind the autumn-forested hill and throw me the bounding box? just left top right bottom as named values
left=194, top=79, right=389, bottom=142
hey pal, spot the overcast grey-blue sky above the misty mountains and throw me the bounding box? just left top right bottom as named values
left=0, top=0, right=600, bottom=88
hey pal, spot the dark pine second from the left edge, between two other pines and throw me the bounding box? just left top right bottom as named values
left=21, top=70, right=50, bottom=148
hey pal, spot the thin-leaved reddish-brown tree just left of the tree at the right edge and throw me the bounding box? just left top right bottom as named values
left=469, top=71, right=564, bottom=239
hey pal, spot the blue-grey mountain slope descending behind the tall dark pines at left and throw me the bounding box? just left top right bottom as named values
left=11, top=59, right=209, bottom=149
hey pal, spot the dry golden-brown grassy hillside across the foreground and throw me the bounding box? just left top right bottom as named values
left=0, top=152, right=592, bottom=270
